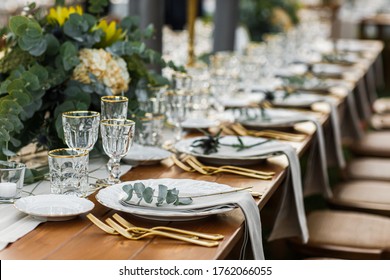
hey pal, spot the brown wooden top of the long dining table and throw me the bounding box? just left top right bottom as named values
left=0, top=38, right=382, bottom=260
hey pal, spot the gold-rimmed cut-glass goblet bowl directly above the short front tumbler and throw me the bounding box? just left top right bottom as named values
left=62, top=111, right=100, bottom=152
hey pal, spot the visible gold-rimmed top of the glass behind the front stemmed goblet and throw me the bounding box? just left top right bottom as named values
left=100, top=95, right=129, bottom=120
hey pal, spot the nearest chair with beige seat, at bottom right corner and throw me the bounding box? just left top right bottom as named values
left=289, top=210, right=390, bottom=259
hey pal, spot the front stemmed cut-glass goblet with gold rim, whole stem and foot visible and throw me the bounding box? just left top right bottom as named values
left=100, top=119, right=135, bottom=185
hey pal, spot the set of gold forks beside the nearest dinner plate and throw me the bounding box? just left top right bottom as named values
left=87, top=213, right=224, bottom=247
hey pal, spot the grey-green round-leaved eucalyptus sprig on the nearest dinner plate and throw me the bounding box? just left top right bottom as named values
left=122, top=182, right=192, bottom=206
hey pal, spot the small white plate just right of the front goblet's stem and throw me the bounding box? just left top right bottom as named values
left=122, top=144, right=171, bottom=165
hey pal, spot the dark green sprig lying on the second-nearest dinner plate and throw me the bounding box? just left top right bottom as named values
left=191, top=129, right=271, bottom=155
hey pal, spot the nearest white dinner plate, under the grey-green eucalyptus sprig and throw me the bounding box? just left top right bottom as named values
left=96, top=178, right=235, bottom=221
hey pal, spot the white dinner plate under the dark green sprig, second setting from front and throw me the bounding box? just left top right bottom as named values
left=175, top=136, right=269, bottom=165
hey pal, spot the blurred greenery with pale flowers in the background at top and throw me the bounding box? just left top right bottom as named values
left=240, top=0, right=301, bottom=42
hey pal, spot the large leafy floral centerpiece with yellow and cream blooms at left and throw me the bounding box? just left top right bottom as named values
left=0, top=0, right=181, bottom=162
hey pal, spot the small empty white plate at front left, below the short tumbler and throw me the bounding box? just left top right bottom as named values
left=14, top=194, right=95, bottom=221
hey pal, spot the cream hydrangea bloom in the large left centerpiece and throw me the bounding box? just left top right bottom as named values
left=72, top=49, right=130, bottom=94
